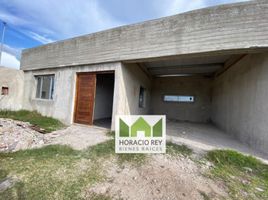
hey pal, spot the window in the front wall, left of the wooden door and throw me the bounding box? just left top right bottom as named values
left=35, top=75, right=54, bottom=99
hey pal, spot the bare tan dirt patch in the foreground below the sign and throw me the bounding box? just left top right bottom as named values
left=84, top=155, right=227, bottom=200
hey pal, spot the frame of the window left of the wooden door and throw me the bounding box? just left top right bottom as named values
left=34, top=74, right=55, bottom=101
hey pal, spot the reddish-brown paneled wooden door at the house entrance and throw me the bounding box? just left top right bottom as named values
left=74, top=73, right=96, bottom=125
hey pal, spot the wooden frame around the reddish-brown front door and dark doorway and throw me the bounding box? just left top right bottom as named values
left=73, top=70, right=115, bottom=126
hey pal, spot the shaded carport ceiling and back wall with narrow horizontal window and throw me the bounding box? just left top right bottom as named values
left=139, top=54, right=246, bottom=123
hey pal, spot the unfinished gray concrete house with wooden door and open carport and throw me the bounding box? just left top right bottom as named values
left=10, top=0, right=268, bottom=152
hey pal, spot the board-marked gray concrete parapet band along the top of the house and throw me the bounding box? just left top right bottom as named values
left=21, top=0, right=268, bottom=70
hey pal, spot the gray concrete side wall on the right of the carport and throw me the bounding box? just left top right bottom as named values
left=212, top=53, right=268, bottom=153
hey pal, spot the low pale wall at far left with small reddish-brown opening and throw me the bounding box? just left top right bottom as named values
left=0, top=67, right=24, bottom=110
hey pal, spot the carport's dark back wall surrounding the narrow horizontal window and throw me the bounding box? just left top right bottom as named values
left=151, top=76, right=212, bottom=122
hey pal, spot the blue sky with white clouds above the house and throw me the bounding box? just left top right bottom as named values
left=0, top=0, right=248, bottom=69
